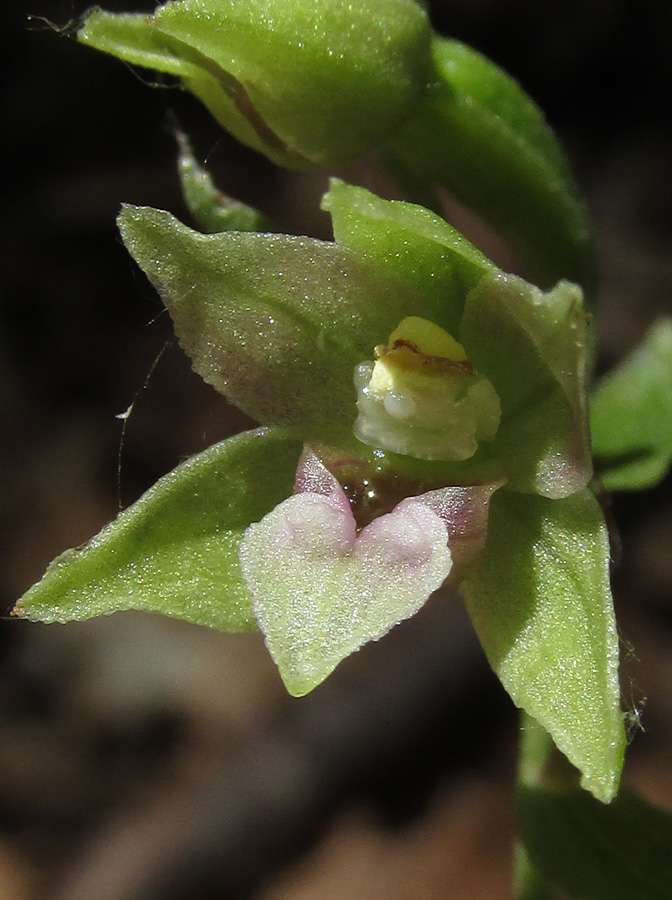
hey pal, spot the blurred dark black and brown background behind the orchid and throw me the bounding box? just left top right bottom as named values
left=0, top=0, right=672, bottom=900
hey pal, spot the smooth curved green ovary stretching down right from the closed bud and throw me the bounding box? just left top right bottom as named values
left=391, top=37, right=594, bottom=290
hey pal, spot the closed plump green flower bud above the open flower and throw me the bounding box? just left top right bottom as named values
left=78, top=0, right=430, bottom=169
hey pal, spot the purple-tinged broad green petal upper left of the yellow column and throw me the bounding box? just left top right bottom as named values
left=119, top=206, right=456, bottom=440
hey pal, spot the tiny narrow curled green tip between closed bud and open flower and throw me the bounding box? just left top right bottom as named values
left=175, top=130, right=270, bottom=234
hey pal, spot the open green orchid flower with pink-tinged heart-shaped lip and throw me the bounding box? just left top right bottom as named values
left=17, top=181, right=624, bottom=801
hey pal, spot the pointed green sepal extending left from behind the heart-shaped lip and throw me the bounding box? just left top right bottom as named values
left=14, top=429, right=301, bottom=631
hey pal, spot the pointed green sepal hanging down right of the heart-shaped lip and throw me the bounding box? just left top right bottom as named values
left=462, top=490, right=625, bottom=802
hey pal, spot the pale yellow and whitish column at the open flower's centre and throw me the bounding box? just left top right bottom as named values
left=354, top=316, right=501, bottom=460
